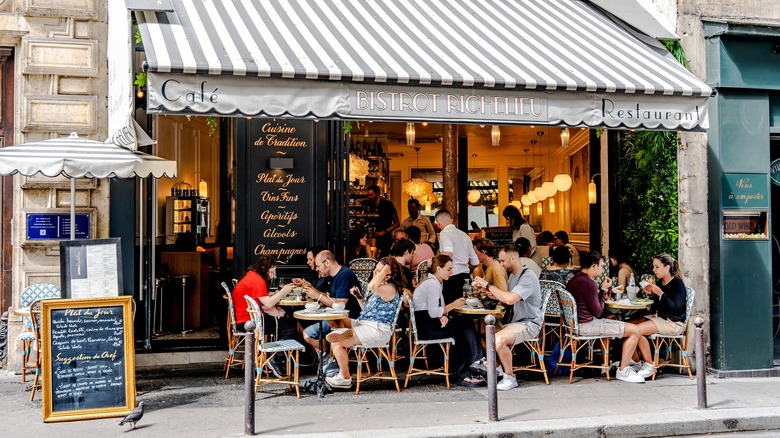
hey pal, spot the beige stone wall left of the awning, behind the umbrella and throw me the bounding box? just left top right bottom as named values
left=0, top=0, right=109, bottom=367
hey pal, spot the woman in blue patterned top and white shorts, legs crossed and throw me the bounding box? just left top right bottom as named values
left=325, top=257, right=406, bottom=388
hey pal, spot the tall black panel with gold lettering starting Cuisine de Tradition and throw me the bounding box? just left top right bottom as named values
left=242, top=119, right=316, bottom=265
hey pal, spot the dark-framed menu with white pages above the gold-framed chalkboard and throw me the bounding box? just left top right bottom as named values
left=60, top=237, right=122, bottom=298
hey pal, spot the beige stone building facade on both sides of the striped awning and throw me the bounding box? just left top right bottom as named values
left=0, top=0, right=780, bottom=374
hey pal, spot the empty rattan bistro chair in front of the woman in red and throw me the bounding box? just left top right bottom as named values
left=244, top=295, right=305, bottom=398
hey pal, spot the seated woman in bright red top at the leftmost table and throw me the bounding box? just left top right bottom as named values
left=231, top=255, right=296, bottom=377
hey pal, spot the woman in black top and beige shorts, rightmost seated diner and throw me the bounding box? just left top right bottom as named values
left=632, top=254, right=687, bottom=379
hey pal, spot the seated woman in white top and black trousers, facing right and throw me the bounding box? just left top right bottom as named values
left=412, top=254, right=484, bottom=387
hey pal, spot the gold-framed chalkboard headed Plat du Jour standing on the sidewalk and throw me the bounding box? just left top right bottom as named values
left=41, top=296, right=135, bottom=423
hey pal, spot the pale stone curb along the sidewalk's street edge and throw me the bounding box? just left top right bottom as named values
left=237, top=407, right=780, bottom=438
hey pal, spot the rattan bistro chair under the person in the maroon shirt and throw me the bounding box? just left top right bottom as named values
left=555, top=290, right=611, bottom=383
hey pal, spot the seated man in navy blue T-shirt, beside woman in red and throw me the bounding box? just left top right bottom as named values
left=303, top=250, right=360, bottom=359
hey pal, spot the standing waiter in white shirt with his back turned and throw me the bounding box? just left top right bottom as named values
left=436, top=209, right=479, bottom=304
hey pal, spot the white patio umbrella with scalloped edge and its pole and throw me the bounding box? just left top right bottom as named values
left=0, top=132, right=176, bottom=240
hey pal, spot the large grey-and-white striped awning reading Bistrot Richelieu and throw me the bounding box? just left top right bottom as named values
left=136, top=0, right=712, bottom=130
